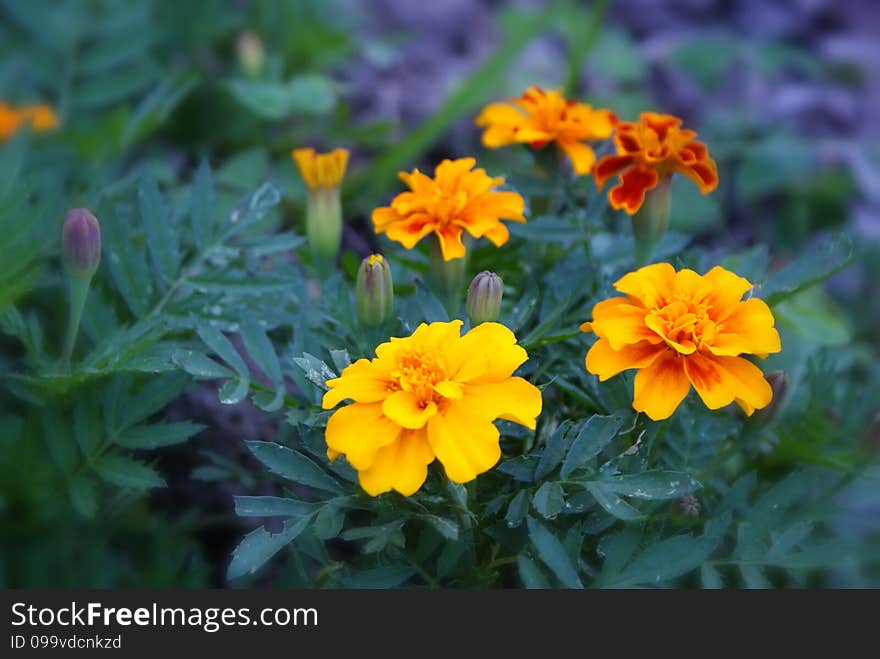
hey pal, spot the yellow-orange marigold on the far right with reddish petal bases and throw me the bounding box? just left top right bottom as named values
left=581, top=263, right=781, bottom=421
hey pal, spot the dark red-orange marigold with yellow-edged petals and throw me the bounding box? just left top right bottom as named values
left=594, top=112, right=718, bottom=215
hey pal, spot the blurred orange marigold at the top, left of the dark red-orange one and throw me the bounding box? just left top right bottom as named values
left=476, top=87, right=617, bottom=176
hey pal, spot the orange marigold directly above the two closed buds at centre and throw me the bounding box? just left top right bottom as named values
left=373, top=158, right=526, bottom=261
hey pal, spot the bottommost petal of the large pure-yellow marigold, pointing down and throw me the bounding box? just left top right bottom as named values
left=358, top=430, right=434, bottom=496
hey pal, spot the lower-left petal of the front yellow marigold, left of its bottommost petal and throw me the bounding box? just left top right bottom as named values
left=324, top=403, right=402, bottom=470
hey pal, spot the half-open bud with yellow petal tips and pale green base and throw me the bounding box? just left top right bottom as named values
left=291, top=149, right=348, bottom=265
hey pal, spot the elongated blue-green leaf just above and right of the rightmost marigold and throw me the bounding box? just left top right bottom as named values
left=761, top=234, right=855, bottom=306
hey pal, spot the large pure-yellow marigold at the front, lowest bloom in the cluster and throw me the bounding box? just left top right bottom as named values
left=323, top=320, right=541, bottom=496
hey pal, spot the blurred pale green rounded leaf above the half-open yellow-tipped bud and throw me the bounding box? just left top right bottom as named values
left=229, top=74, right=337, bottom=120
